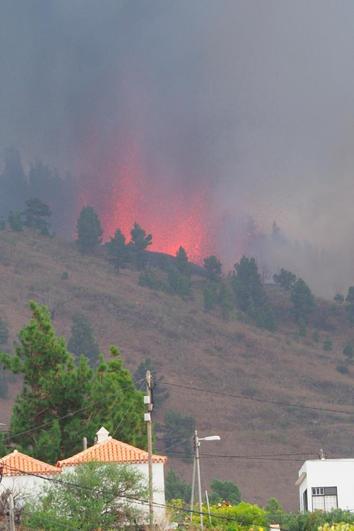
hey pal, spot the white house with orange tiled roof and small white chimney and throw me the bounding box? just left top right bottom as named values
left=57, top=427, right=167, bottom=521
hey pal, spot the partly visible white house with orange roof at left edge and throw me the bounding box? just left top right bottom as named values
left=0, top=450, right=60, bottom=499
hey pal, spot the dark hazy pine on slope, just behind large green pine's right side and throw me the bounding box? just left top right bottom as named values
left=68, top=314, right=100, bottom=366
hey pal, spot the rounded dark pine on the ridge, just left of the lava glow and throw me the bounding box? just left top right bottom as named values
left=77, top=206, right=103, bottom=253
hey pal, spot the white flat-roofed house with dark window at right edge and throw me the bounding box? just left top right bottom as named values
left=295, top=456, right=354, bottom=512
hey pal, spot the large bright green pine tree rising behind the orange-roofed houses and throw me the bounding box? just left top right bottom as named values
left=0, top=302, right=145, bottom=463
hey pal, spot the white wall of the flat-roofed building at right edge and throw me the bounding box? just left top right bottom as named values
left=299, top=459, right=354, bottom=511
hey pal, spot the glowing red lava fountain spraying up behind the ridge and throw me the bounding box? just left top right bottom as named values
left=80, top=140, right=215, bottom=263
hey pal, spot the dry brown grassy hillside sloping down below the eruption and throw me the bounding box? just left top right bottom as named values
left=0, top=231, right=354, bottom=509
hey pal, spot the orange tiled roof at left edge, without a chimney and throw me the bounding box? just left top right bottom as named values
left=0, top=450, right=60, bottom=476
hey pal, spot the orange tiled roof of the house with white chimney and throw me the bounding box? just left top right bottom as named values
left=57, top=438, right=167, bottom=467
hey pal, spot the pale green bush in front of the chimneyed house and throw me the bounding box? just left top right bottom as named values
left=23, top=463, right=147, bottom=531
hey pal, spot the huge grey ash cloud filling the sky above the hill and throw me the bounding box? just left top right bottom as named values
left=0, top=0, right=354, bottom=295
